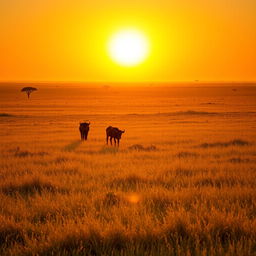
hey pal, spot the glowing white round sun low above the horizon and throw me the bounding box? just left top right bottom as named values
left=108, top=29, right=149, bottom=66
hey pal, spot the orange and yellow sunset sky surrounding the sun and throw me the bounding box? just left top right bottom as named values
left=0, top=0, right=256, bottom=81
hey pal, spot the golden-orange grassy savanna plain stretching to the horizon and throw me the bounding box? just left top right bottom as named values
left=0, top=83, right=256, bottom=256
